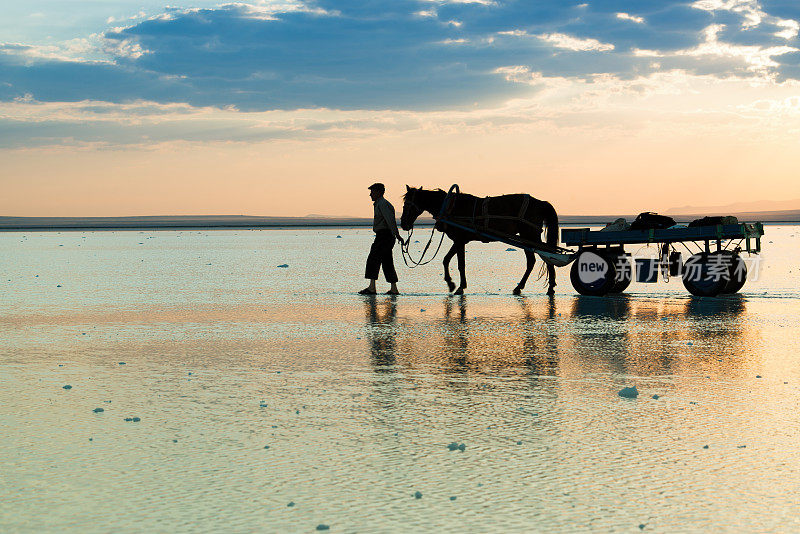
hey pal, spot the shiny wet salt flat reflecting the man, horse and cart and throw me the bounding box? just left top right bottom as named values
left=0, top=226, right=800, bottom=532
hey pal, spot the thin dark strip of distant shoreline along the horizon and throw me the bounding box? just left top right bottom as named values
left=0, top=210, right=800, bottom=232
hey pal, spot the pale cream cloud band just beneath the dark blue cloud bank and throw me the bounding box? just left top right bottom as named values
left=6, top=66, right=800, bottom=149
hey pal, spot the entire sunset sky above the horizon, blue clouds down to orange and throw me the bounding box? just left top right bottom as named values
left=0, top=0, right=800, bottom=216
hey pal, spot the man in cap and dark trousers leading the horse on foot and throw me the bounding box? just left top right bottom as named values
left=359, top=183, right=403, bottom=295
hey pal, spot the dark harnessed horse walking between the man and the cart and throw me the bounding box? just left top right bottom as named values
left=400, top=185, right=558, bottom=295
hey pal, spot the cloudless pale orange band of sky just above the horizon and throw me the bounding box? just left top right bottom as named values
left=0, top=122, right=800, bottom=216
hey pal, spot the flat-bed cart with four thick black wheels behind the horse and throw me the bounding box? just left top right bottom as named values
left=561, top=223, right=764, bottom=297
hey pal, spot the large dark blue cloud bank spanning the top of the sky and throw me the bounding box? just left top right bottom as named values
left=0, top=0, right=800, bottom=147
